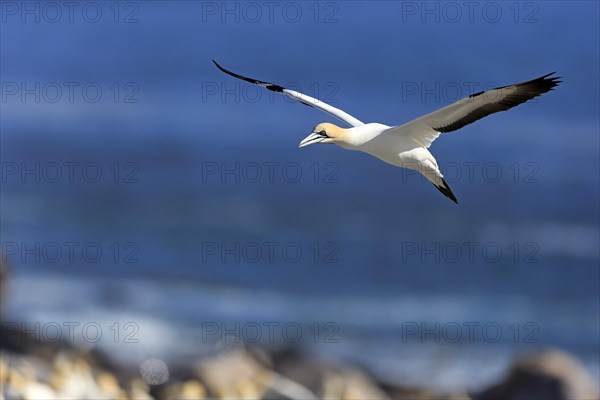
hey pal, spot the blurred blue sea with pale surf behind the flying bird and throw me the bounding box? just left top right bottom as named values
left=0, top=1, right=600, bottom=391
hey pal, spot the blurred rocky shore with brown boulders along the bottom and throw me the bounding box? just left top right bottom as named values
left=0, top=266, right=600, bottom=400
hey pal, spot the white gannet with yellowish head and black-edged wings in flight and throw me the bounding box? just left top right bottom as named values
left=213, top=60, right=562, bottom=204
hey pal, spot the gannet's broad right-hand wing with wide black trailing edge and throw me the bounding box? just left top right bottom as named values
left=386, top=72, right=562, bottom=147
